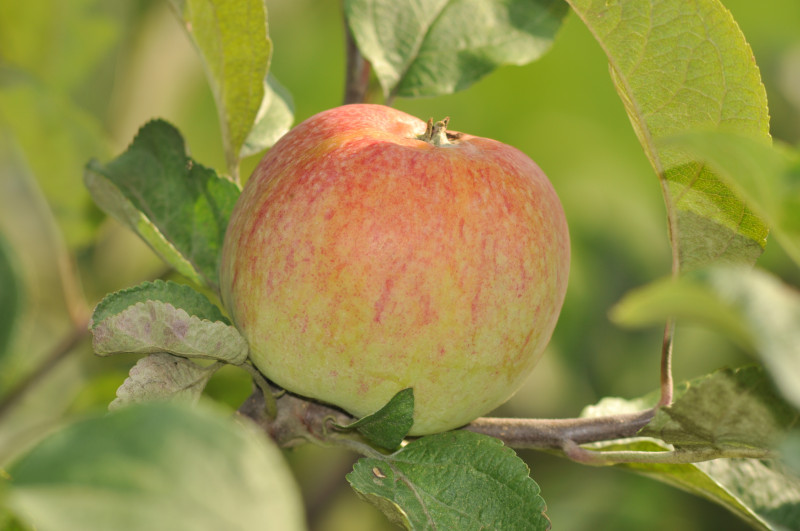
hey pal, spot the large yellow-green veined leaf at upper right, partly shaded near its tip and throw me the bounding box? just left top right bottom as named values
left=568, top=0, right=769, bottom=271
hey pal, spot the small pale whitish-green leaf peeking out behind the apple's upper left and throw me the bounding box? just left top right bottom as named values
left=241, top=74, right=294, bottom=157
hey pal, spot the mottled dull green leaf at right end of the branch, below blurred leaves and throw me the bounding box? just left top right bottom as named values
left=639, top=367, right=800, bottom=450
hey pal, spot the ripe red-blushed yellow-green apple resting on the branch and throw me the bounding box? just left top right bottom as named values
left=220, top=104, right=570, bottom=435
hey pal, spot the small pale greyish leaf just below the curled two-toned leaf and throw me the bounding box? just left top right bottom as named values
left=108, top=352, right=222, bottom=411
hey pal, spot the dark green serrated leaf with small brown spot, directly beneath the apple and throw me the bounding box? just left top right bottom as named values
left=347, top=431, right=550, bottom=530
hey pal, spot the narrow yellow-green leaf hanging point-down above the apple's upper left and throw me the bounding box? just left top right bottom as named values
left=172, top=0, right=272, bottom=176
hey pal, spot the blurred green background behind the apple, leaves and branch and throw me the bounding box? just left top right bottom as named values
left=0, top=0, right=800, bottom=531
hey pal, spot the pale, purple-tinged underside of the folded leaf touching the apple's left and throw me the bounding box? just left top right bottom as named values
left=92, top=300, right=248, bottom=365
